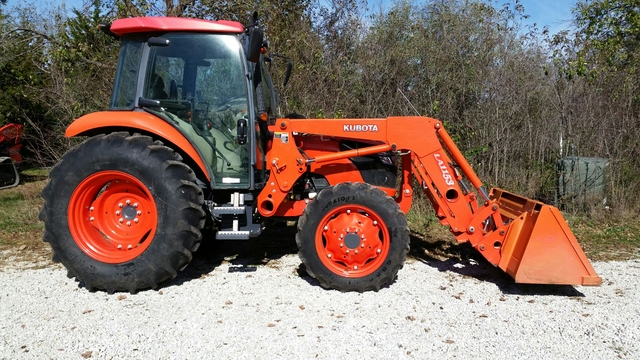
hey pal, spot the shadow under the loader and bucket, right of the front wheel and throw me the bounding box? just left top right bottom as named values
left=409, top=234, right=585, bottom=297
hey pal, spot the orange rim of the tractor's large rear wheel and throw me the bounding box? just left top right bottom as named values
left=67, top=170, right=158, bottom=264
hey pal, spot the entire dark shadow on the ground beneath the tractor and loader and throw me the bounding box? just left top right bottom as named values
left=164, top=229, right=585, bottom=297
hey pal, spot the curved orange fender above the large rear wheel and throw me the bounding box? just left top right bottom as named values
left=65, top=111, right=211, bottom=181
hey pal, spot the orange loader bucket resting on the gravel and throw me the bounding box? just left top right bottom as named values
left=491, top=189, right=602, bottom=285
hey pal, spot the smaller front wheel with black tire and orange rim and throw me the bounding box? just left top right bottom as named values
left=296, top=183, right=409, bottom=292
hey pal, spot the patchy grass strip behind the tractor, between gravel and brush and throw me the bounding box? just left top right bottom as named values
left=0, top=169, right=640, bottom=263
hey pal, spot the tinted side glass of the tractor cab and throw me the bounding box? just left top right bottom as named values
left=112, top=33, right=250, bottom=188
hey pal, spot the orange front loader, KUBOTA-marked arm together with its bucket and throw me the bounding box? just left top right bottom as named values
left=258, top=117, right=602, bottom=285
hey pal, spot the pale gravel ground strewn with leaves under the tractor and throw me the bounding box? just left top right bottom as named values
left=0, top=239, right=640, bottom=359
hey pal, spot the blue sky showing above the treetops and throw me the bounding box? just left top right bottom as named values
left=7, top=0, right=577, bottom=33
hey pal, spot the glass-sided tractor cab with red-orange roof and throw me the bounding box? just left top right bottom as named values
left=109, top=18, right=276, bottom=190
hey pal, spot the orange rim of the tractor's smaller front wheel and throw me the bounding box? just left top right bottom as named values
left=315, top=205, right=390, bottom=278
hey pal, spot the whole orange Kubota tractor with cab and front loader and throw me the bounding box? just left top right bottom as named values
left=40, top=17, right=601, bottom=292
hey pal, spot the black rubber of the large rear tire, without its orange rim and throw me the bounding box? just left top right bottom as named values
left=39, top=132, right=206, bottom=293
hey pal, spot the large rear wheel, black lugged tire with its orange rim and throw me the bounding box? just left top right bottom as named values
left=40, top=132, right=205, bottom=293
